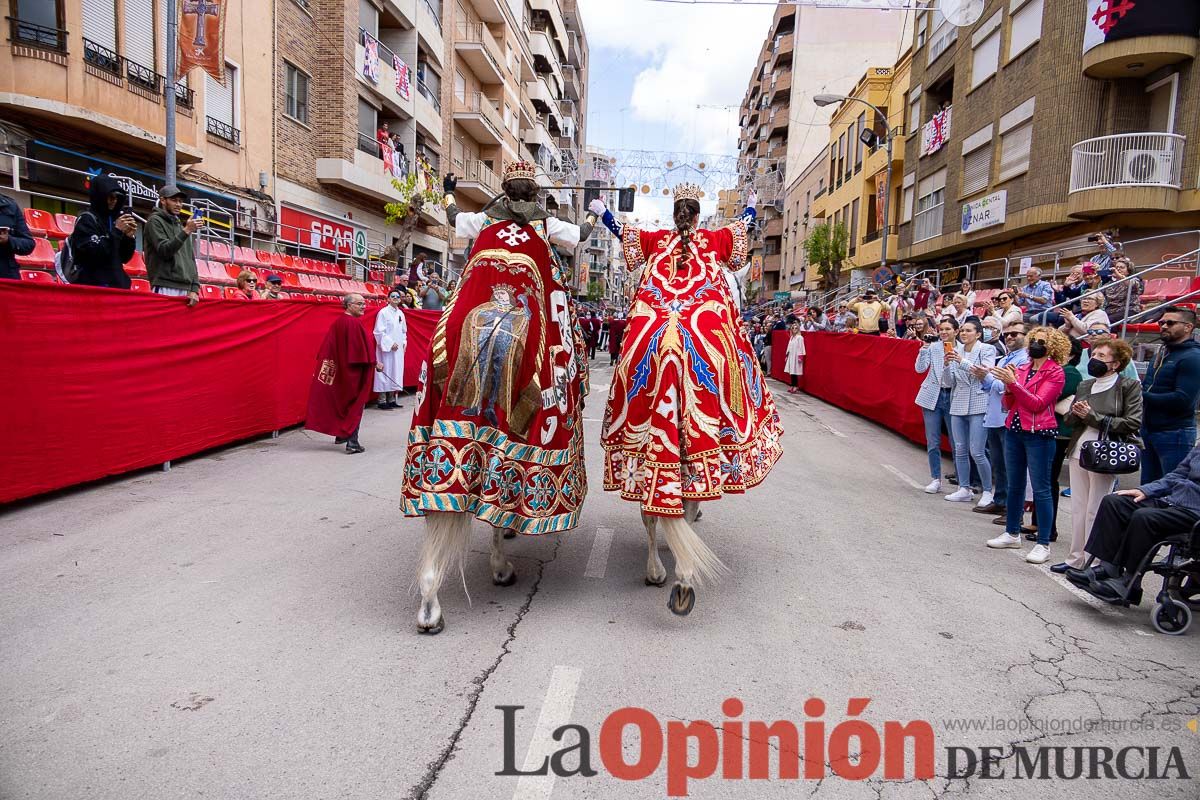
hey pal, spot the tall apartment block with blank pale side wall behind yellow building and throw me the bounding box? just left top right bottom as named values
left=731, top=4, right=907, bottom=297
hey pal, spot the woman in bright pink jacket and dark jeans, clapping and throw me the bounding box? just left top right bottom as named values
left=988, top=327, right=1070, bottom=564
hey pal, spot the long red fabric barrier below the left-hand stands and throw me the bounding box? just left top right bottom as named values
left=0, top=281, right=439, bottom=503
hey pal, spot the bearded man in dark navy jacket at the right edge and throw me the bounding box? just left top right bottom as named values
left=1141, top=306, right=1200, bottom=485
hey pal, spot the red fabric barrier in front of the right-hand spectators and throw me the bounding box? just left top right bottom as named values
left=770, top=331, right=925, bottom=444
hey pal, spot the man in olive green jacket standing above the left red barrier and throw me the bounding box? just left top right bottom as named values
left=143, top=184, right=200, bottom=306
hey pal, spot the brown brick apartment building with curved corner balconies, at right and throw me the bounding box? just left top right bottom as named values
left=899, top=0, right=1200, bottom=277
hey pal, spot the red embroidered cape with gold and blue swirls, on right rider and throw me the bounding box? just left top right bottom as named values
left=602, top=222, right=782, bottom=516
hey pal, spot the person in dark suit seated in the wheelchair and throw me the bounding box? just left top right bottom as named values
left=1066, top=445, right=1200, bottom=606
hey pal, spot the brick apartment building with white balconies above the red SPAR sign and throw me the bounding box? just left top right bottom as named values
left=274, top=0, right=448, bottom=264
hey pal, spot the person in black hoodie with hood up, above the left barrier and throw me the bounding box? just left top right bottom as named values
left=68, top=175, right=137, bottom=289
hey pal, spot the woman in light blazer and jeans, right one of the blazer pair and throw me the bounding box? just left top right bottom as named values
left=943, top=317, right=996, bottom=506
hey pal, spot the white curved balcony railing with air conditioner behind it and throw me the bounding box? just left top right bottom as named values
left=1070, top=133, right=1187, bottom=192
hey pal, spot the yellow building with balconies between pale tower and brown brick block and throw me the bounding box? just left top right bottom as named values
left=812, top=50, right=912, bottom=283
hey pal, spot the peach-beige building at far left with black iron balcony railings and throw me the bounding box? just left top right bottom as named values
left=0, top=0, right=276, bottom=240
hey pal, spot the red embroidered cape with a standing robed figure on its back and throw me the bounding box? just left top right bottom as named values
left=403, top=215, right=587, bottom=534
